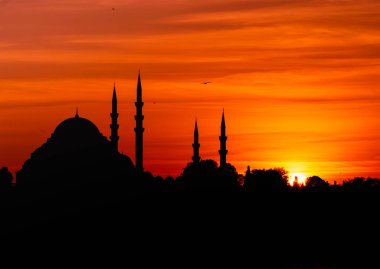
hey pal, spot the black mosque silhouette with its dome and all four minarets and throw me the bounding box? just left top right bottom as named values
left=16, top=71, right=228, bottom=187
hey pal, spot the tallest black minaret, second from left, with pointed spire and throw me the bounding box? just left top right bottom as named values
left=135, top=71, right=144, bottom=172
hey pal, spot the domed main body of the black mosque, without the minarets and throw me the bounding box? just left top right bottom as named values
left=16, top=109, right=135, bottom=188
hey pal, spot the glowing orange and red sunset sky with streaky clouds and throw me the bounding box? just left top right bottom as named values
left=0, top=0, right=380, bottom=182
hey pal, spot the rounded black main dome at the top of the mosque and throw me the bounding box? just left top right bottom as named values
left=52, top=115, right=102, bottom=140
